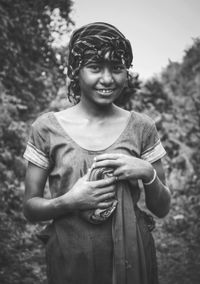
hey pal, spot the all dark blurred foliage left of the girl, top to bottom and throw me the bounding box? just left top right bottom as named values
left=0, top=0, right=73, bottom=284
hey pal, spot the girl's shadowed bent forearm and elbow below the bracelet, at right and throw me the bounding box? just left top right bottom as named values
left=144, top=177, right=171, bottom=218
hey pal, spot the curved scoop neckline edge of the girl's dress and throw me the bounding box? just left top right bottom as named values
left=50, top=111, right=133, bottom=154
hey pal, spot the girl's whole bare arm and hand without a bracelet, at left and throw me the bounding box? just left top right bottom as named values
left=24, top=162, right=115, bottom=222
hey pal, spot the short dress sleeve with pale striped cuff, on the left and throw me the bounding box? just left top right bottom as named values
left=23, top=117, right=50, bottom=170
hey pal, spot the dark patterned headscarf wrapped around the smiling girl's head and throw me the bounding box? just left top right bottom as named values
left=67, top=22, right=133, bottom=103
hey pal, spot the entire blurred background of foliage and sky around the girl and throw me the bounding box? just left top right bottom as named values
left=0, top=0, right=200, bottom=284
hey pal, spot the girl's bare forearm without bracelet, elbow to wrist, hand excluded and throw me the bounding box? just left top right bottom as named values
left=24, top=193, right=75, bottom=222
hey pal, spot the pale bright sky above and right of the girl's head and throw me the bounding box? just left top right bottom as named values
left=71, top=0, right=200, bottom=79
